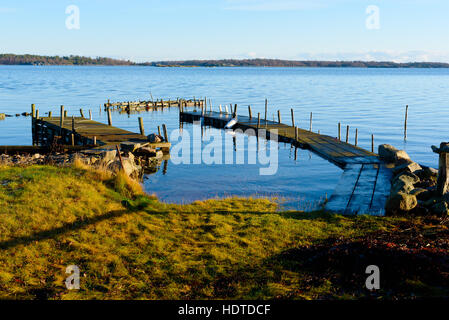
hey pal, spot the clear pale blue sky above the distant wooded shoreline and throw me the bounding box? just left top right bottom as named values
left=0, top=0, right=449, bottom=62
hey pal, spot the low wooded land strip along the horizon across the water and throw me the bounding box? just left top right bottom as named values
left=0, top=54, right=449, bottom=68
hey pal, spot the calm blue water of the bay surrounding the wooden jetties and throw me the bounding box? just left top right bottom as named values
left=0, top=66, right=449, bottom=207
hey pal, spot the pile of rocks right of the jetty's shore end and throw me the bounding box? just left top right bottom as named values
left=379, top=144, right=449, bottom=216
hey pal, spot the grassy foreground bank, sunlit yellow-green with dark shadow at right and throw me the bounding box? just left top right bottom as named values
left=0, top=166, right=448, bottom=299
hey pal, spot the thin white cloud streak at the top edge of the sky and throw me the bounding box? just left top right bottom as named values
left=225, top=0, right=326, bottom=11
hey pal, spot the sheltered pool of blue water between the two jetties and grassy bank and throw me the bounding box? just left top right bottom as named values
left=144, top=120, right=341, bottom=210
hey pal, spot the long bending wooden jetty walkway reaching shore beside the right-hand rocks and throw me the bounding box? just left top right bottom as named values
left=180, top=107, right=392, bottom=216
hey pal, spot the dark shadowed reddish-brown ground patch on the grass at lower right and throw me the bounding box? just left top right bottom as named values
left=276, top=218, right=449, bottom=299
